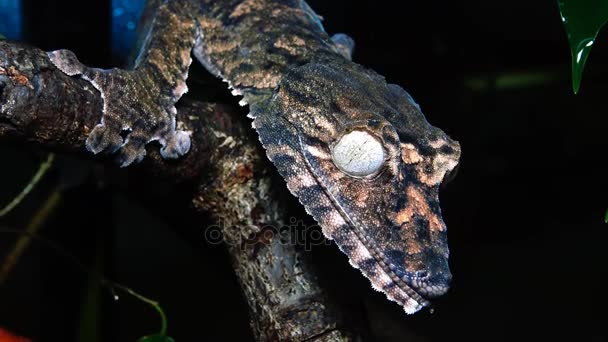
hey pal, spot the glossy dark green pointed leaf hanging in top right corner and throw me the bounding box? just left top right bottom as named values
left=557, top=0, right=608, bottom=94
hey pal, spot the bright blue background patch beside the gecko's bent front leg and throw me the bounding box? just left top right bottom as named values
left=112, top=0, right=144, bottom=57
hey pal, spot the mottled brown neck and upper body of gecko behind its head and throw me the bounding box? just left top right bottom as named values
left=194, top=0, right=341, bottom=99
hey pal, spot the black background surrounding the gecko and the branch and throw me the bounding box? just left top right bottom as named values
left=0, top=0, right=608, bottom=341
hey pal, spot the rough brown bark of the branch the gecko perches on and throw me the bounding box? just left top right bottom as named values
left=0, top=41, right=352, bottom=341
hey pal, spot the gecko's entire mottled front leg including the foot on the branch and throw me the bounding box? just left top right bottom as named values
left=49, top=1, right=199, bottom=166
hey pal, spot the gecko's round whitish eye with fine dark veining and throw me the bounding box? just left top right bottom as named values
left=331, top=131, right=385, bottom=177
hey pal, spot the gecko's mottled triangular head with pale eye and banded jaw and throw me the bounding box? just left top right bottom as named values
left=255, top=56, right=460, bottom=313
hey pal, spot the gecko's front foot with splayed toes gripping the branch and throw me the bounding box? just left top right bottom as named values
left=48, top=50, right=190, bottom=166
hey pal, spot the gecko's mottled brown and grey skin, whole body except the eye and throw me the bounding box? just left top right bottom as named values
left=49, top=0, right=460, bottom=313
